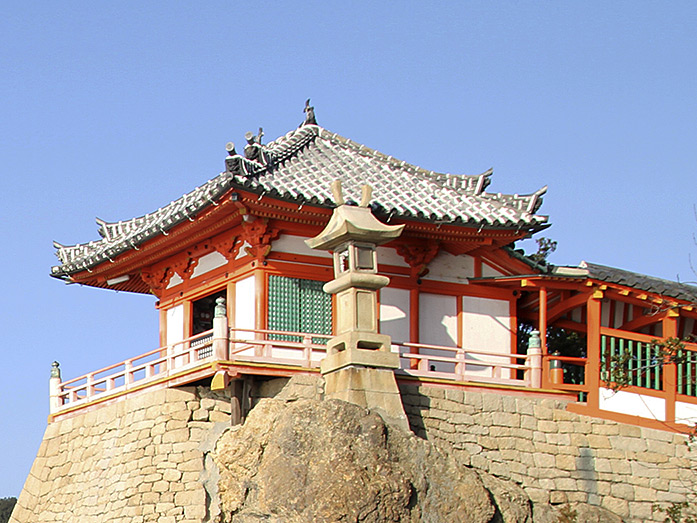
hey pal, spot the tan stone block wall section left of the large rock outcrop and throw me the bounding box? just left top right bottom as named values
left=10, top=387, right=230, bottom=523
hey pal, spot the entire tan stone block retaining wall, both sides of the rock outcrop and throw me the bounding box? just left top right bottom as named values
left=10, top=376, right=697, bottom=523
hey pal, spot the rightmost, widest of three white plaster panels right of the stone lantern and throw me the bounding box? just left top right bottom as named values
left=462, top=296, right=513, bottom=378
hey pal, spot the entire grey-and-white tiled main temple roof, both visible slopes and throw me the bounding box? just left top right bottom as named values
left=51, top=125, right=547, bottom=278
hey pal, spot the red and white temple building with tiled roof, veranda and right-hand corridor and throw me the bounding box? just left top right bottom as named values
left=51, top=102, right=697, bottom=430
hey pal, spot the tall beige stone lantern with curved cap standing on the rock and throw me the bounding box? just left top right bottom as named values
left=306, top=180, right=409, bottom=430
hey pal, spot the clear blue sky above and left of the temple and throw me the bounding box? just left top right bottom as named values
left=0, top=0, right=697, bottom=497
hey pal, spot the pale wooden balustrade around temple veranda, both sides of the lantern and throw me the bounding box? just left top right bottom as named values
left=51, top=328, right=539, bottom=414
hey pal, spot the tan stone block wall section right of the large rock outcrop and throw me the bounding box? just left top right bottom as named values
left=400, top=384, right=697, bottom=523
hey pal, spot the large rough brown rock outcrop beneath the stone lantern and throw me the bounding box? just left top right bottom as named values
left=207, top=399, right=620, bottom=523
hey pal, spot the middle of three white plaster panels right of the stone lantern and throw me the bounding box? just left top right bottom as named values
left=419, top=292, right=457, bottom=372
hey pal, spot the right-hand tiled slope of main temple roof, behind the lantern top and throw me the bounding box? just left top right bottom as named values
left=227, top=125, right=547, bottom=229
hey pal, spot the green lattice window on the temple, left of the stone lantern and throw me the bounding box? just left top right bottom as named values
left=269, top=275, right=332, bottom=343
